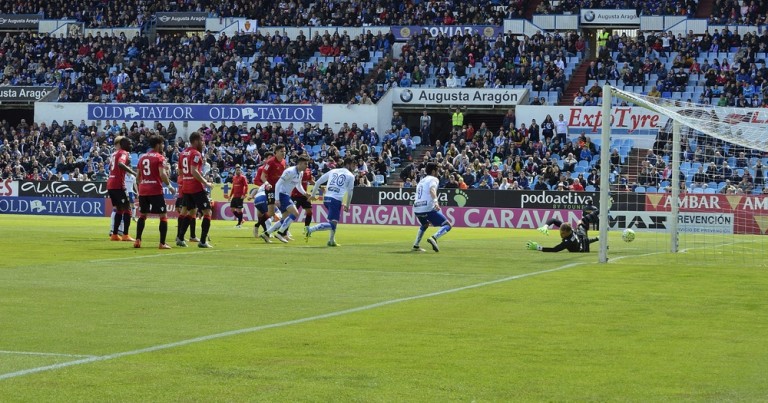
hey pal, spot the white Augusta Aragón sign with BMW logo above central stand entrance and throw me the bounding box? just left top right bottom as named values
left=393, top=88, right=528, bottom=106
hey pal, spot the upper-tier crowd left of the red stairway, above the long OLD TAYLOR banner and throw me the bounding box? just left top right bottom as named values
left=0, top=27, right=585, bottom=104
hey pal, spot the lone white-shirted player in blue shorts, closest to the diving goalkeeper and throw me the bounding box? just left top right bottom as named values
left=413, top=162, right=451, bottom=252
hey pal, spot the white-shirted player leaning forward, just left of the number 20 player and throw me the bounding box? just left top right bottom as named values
left=259, top=155, right=309, bottom=243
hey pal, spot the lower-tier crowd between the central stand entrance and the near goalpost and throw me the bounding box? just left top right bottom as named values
left=401, top=110, right=608, bottom=191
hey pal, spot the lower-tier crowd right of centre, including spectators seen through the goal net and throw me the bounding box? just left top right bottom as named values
left=400, top=106, right=768, bottom=194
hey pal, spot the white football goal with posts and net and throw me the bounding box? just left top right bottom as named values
left=599, top=85, right=768, bottom=267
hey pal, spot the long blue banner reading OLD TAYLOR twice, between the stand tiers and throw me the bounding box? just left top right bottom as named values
left=88, top=104, right=323, bottom=123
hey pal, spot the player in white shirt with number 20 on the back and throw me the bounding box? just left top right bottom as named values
left=304, top=157, right=356, bottom=246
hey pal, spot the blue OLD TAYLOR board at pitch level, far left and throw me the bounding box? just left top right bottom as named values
left=0, top=197, right=106, bottom=217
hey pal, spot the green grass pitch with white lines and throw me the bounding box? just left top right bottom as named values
left=0, top=215, right=768, bottom=402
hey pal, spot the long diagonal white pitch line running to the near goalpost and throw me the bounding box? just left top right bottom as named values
left=0, top=262, right=588, bottom=381
